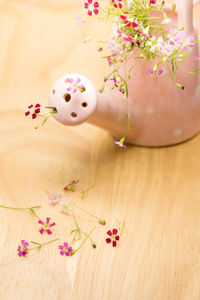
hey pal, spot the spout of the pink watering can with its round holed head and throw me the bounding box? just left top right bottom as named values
left=49, top=74, right=127, bottom=136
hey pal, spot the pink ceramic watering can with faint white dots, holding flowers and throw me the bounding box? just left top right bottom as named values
left=49, top=0, right=200, bottom=146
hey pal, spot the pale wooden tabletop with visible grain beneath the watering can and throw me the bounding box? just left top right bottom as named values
left=0, top=0, right=200, bottom=300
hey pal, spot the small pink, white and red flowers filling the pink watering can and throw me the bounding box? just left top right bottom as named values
left=25, top=0, right=200, bottom=148
